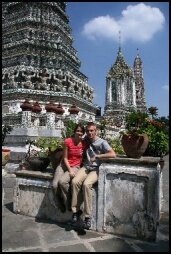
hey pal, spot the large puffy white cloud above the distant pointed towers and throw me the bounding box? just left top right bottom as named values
left=83, top=3, right=165, bottom=42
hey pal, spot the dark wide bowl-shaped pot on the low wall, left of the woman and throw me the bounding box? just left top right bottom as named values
left=24, top=157, right=50, bottom=171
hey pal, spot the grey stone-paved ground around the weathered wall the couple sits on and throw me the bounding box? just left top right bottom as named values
left=2, top=156, right=169, bottom=252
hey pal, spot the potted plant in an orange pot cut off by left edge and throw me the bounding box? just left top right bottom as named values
left=2, top=125, right=13, bottom=166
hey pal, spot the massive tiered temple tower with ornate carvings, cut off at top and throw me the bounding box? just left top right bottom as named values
left=2, top=2, right=97, bottom=120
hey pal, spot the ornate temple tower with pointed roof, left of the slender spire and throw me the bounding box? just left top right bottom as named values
left=104, top=46, right=136, bottom=124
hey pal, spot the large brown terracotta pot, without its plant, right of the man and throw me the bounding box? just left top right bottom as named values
left=121, top=134, right=149, bottom=158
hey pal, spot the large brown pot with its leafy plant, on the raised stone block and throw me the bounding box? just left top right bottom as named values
left=120, top=111, right=149, bottom=158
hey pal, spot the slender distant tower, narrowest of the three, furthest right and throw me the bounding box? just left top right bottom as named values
left=133, top=49, right=147, bottom=112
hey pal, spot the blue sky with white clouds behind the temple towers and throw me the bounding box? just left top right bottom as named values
left=66, top=2, right=169, bottom=116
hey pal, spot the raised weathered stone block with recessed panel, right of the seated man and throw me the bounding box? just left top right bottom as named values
left=97, top=157, right=161, bottom=241
